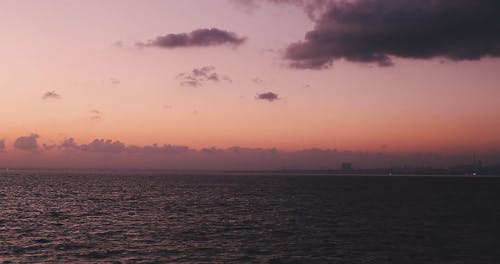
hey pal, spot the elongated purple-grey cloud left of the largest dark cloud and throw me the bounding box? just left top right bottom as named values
left=136, top=28, right=246, bottom=49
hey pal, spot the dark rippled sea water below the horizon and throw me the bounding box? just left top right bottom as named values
left=0, top=173, right=500, bottom=263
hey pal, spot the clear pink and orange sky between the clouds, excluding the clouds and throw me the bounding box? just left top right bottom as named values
left=0, top=0, right=500, bottom=168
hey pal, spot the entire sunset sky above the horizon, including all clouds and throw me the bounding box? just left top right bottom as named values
left=0, top=0, right=500, bottom=169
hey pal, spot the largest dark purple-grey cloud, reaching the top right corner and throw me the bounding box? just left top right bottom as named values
left=282, top=0, right=500, bottom=69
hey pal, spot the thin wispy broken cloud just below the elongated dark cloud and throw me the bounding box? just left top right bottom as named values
left=175, top=66, right=232, bottom=87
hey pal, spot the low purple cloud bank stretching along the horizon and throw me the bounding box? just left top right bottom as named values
left=0, top=134, right=500, bottom=170
